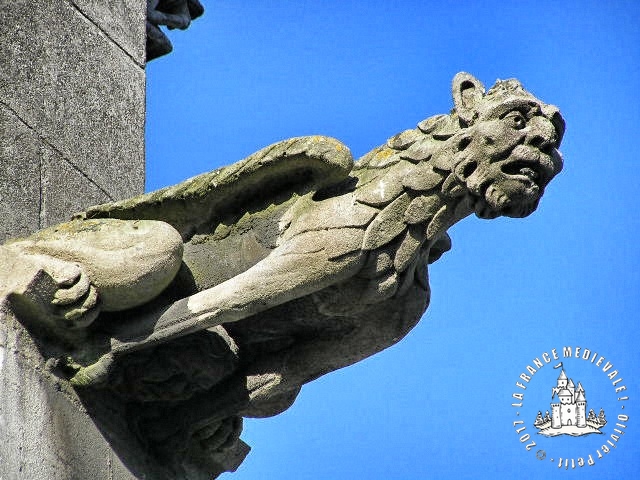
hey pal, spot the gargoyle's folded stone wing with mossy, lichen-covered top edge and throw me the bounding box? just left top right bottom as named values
left=76, top=136, right=353, bottom=241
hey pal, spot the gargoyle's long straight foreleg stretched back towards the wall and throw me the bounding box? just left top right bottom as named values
left=71, top=228, right=366, bottom=386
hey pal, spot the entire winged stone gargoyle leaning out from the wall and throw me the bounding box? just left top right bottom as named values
left=0, top=73, right=564, bottom=478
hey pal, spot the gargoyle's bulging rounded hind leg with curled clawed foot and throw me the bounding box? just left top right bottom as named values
left=0, top=219, right=183, bottom=347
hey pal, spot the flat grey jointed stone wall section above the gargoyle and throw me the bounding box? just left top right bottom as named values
left=0, top=0, right=146, bottom=241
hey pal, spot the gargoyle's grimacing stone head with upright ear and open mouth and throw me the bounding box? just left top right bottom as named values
left=453, top=73, right=564, bottom=218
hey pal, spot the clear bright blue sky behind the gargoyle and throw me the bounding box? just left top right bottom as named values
left=147, top=0, right=640, bottom=480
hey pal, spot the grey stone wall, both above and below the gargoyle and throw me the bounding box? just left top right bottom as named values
left=0, top=0, right=148, bottom=480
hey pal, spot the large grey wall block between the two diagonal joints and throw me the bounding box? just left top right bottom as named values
left=0, top=0, right=145, bottom=198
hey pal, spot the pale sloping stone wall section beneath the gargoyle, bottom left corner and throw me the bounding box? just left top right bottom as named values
left=0, top=309, right=156, bottom=480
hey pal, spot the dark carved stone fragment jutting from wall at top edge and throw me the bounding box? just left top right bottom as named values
left=147, top=0, right=204, bottom=62
